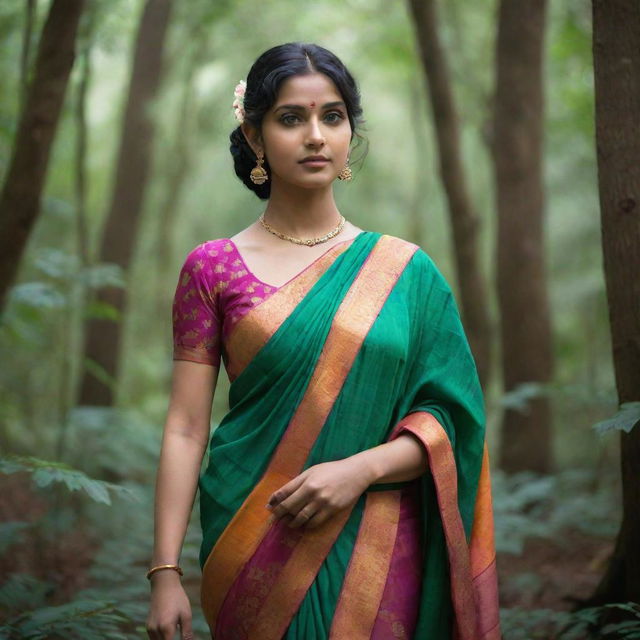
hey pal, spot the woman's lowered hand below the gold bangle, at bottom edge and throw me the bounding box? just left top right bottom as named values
left=146, top=570, right=193, bottom=640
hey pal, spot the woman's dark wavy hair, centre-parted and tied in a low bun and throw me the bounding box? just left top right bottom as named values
left=229, top=42, right=366, bottom=200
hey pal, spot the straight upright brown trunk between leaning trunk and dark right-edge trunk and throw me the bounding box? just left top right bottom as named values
left=492, top=0, right=553, bottom=473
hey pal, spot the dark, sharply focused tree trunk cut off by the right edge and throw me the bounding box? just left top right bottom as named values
left=589, top=0, right=640, bottom=605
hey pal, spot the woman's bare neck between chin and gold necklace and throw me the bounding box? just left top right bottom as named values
left=264, top=176, right=340, bottom=238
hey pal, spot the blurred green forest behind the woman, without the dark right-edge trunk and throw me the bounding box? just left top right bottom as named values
left=0, top=0, right=640, bottom=640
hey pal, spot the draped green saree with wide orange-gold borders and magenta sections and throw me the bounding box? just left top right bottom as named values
left=199, top=231, right=499, bottom=640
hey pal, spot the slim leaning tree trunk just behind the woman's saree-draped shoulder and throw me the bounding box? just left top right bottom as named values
left=409, top=0, right=491, bottom=388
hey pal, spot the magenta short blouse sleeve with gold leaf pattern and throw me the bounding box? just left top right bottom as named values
left=172, top=244, right=221, bottom=367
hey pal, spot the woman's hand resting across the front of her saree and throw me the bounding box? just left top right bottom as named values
left=267, top=457, right=372, bottom=529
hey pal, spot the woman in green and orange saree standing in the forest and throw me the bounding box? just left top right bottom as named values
left=147, top=43, right=499, bottom=640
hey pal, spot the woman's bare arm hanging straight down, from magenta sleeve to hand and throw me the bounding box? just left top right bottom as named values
left=147, top=360, right=219, bottom=638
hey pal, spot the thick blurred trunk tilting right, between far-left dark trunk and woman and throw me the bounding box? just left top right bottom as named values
left=79, top=0, right=171, bottom=406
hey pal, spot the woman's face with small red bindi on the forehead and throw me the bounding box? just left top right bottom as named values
left=242, top=73, right=351, bottom=188
